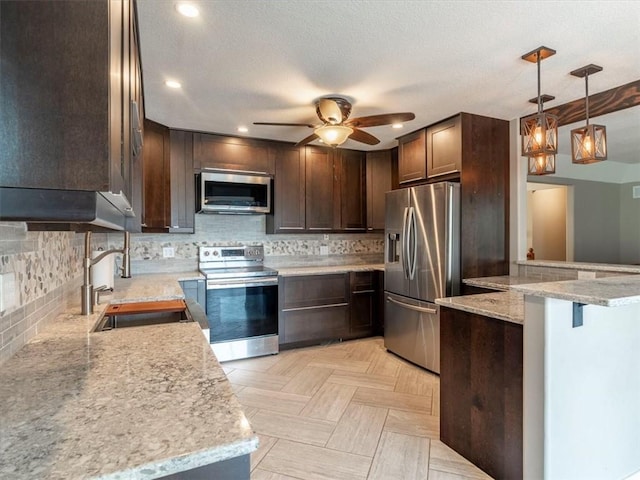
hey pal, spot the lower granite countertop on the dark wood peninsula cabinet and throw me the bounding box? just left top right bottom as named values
left=436, top=291, right=524, bottom=325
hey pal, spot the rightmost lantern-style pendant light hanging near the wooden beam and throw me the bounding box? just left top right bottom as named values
left=571, top=64, right=607, bottom=164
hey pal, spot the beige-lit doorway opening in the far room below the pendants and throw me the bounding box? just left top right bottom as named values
left=527, top=182, right=573, bottom=262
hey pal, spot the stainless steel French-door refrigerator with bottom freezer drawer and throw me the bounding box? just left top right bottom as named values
left=384, top=182, right=460, bottom=373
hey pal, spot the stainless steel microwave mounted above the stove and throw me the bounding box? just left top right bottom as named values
left=198, top=170, right=271, bottom=213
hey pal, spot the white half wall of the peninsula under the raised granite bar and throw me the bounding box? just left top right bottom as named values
left=524, top=297, right=640, bottom=480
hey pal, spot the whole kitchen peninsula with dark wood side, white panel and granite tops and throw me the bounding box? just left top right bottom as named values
left=436, top=262, right=640, bottom=479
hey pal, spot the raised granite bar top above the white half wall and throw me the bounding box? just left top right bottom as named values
left=512, top=275, right=640, bottom=307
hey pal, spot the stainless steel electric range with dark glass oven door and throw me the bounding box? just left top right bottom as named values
left=198, top=245, right=278, bottom=362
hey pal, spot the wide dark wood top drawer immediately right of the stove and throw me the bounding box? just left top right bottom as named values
left=280, top=273, right=349, bottom=311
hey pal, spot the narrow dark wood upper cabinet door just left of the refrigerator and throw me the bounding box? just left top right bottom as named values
left=366, top=150, right=393, bottom=231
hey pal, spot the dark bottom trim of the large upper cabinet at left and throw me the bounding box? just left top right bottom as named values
left=0, top=187, right=135, bottom=230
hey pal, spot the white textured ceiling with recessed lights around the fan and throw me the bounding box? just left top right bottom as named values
left=138, top=0, right=640, bottom=162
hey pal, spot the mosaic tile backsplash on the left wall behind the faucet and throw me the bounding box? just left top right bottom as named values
left=0, top=222, right=107, bottom=364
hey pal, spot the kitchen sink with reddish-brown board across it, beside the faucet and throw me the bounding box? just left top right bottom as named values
left=93, top=300, right=193, bottom=332
